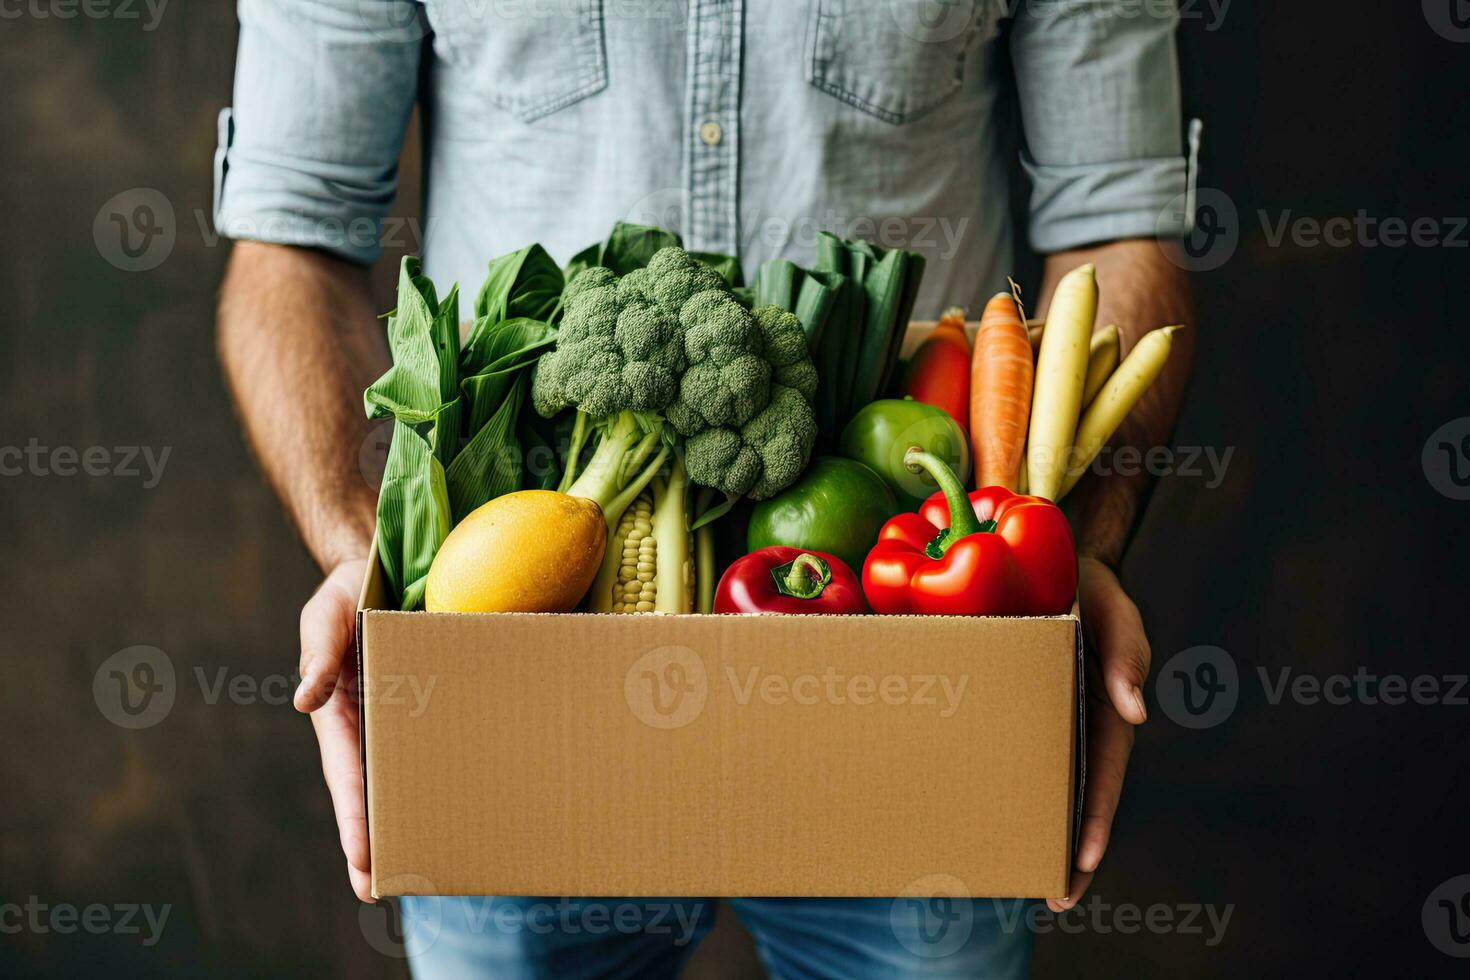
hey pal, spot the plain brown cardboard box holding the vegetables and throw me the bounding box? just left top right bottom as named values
left=357, top=320, right=1083, bottom=898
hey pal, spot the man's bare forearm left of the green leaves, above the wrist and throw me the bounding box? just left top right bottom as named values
left=218, top=242, right=388, bottom=569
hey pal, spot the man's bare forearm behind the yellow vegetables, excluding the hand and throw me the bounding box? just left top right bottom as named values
left=1038, top=239, right=1194, bottom=567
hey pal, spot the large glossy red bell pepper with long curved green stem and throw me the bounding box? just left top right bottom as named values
left=863, top=448, right=1078, bottom=616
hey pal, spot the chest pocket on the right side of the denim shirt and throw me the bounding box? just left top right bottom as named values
left=807, top=0, right=1004, bottom=125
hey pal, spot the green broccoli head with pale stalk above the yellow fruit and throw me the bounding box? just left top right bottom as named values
left=531, top=247, right=817, bottom=520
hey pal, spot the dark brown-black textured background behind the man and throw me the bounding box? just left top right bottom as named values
left=0, top=0, right=1470, bottom=977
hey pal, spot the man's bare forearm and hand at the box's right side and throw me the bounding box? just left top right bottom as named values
left=1041, top=239, right=1195, bottom=912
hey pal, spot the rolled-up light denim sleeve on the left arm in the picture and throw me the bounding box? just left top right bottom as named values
left=215, top=0, right=425, bottom=264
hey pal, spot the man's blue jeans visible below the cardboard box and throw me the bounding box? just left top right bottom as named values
left=400, top=896, right=1032, bottom=980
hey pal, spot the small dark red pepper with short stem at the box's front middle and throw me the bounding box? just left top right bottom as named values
left=714, top=545, right=867, bottom=614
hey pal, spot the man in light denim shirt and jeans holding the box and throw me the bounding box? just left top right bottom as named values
left=216, top=0, right=1191, bottom=977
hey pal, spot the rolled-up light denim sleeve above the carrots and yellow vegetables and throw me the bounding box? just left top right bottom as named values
left=1010, top=0, right=1186, bottom=253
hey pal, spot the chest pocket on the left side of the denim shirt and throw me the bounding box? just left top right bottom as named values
left=425, top=0, right=607, bottom=122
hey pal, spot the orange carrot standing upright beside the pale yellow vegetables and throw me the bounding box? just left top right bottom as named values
left=970, top=292, right=1035, bottom=491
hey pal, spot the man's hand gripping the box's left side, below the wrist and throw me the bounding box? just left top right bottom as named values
left=295, top=558, right=373, bottom=902
